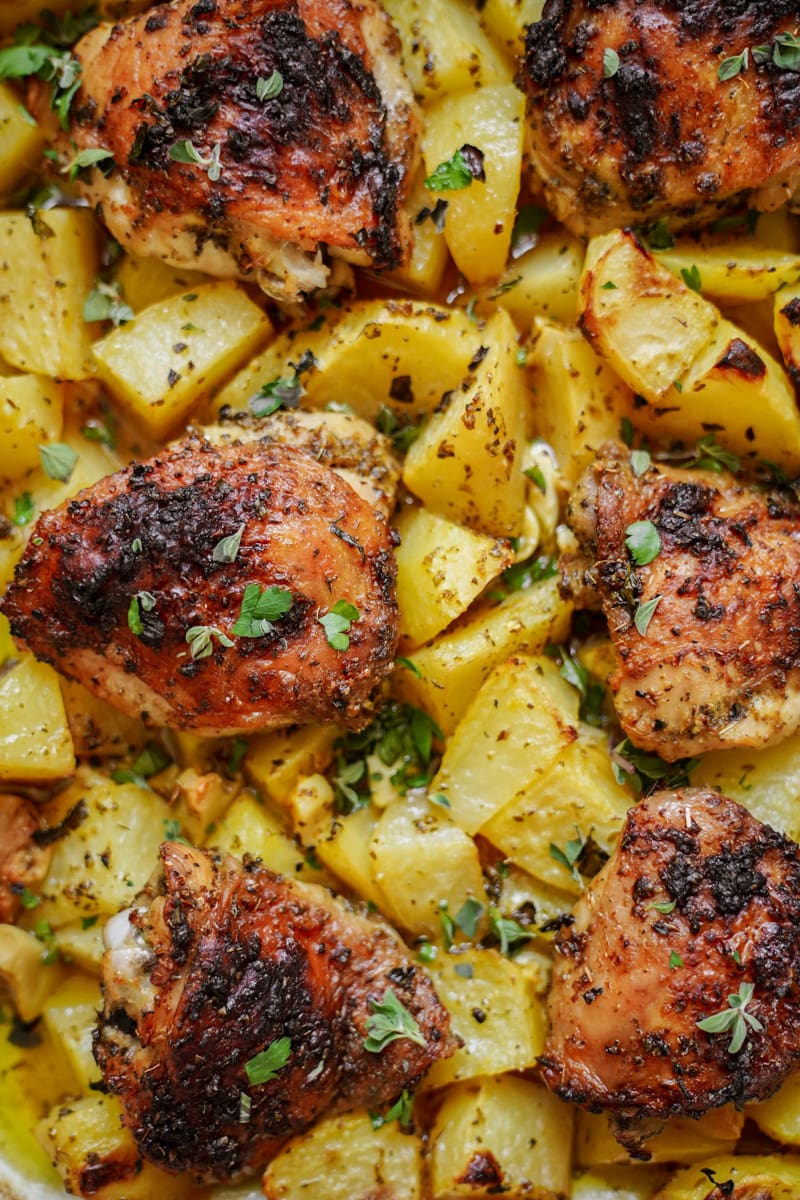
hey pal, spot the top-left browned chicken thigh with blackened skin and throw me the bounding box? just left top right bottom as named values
left=65, top=0, right=417, bottom=299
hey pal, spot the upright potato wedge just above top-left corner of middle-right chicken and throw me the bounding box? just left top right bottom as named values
left=528, top=323, right=633, bottom=487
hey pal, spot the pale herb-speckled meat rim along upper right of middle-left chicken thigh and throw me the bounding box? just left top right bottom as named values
left=201, top=409, right=401, bottom=520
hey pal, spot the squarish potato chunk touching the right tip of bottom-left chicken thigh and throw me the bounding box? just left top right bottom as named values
left=423, top=949, right=546, bottom=1088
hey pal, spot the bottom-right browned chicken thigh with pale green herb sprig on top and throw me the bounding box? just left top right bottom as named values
left=540, top=788, right=800, bottom=1157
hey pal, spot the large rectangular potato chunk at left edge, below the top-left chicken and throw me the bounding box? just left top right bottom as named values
left=0, top=209, right=100, bottom=379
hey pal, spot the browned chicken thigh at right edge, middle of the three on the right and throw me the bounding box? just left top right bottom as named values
left=570, top=443, right=800, bottom=762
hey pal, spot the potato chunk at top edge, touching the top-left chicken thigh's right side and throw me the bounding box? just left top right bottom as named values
left=384, top=0, right=511, bottom=101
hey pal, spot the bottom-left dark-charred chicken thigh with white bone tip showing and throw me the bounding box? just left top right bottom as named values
left=95, top=842, right=457, bottom=1181
